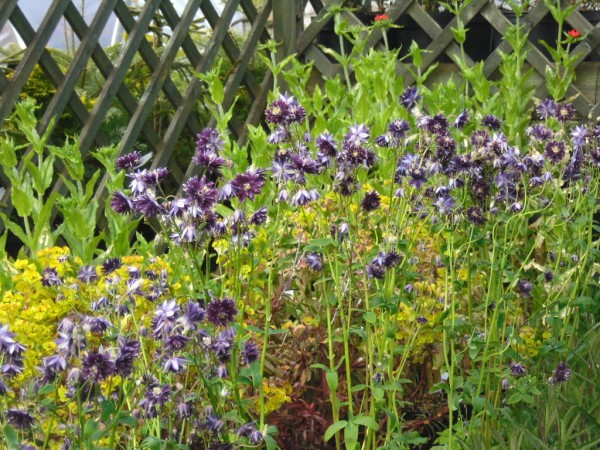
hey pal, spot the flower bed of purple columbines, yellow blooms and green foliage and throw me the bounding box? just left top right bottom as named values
left=0, top=1, right=600, bottom=449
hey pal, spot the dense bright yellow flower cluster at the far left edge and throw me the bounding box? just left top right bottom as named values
left=0, top=247, right=175, bottom=385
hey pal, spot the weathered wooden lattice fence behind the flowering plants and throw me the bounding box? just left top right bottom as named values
left=0, top=0, right=600, bottom=237
